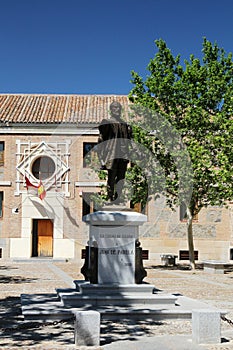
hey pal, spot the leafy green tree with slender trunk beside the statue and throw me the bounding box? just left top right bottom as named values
left=128, top=38, right=233, bottom=268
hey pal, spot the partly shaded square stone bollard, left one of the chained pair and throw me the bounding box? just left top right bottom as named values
left=73, top=311, right=100, bottom=346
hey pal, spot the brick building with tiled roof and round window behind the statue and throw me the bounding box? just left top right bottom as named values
left=0, top=94, right=233, bottom=263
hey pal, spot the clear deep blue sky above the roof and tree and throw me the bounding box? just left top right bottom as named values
left=0, top=0, right=233, bottom=94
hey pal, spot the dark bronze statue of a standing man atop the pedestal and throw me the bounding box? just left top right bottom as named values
left=99, top=101, right=132, bottom=203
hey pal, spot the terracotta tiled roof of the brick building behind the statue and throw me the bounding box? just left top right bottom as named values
left=0, top=94, right=129, bottom=124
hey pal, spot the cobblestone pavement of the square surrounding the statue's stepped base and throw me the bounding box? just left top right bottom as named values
left=0, top=259, right=233, bottom=350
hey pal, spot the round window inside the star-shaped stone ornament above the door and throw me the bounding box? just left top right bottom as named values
left=32, top=156, right=55, bottom=180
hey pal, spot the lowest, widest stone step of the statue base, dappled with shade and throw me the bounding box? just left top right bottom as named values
left=21, top=294, right=191, bottom=322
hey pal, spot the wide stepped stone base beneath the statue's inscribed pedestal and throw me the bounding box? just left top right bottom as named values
left=21, top=281, right=226, bottom=321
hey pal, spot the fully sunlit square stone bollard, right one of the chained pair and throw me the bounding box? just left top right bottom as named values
left=192, top=309, right=221, bottom=344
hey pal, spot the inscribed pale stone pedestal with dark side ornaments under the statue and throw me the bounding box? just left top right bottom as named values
left=82, top=206, right=147, bottom=284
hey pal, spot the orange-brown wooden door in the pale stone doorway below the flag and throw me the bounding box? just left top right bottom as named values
left=34, top=219, right=53, bottom=257
